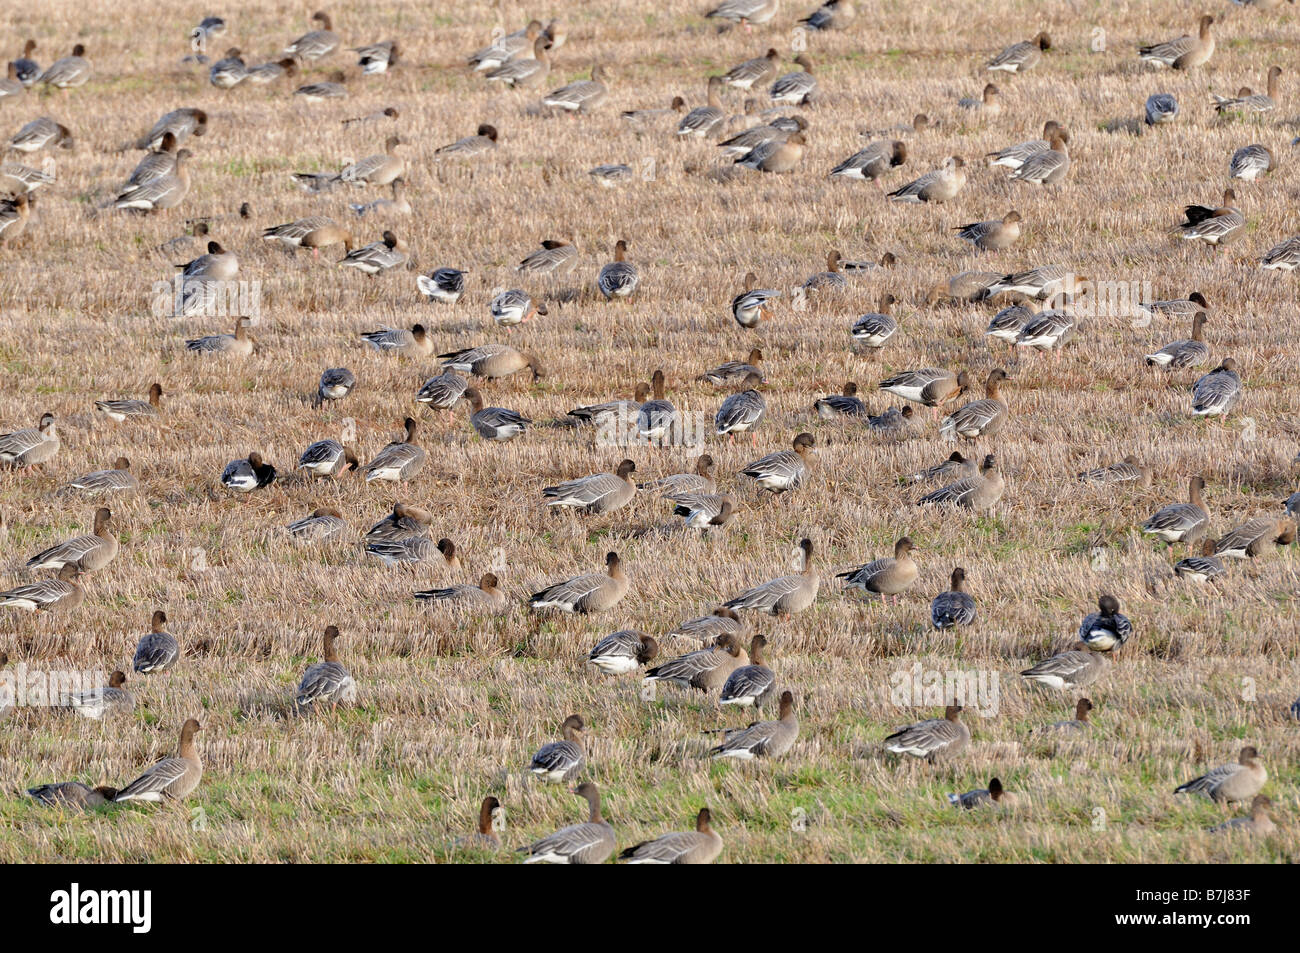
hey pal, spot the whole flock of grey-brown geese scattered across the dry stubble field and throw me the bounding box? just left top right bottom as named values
left=0, top=0, right=1300, bottom=863
